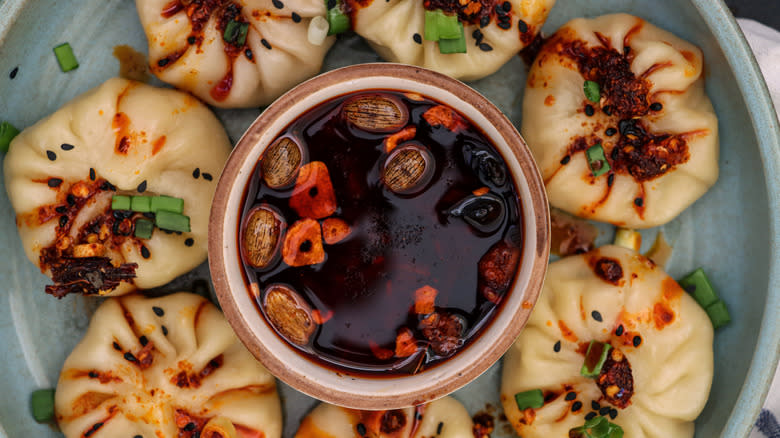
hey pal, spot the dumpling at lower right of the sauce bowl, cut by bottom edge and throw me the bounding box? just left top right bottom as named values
left=501, top=246, right=713, bottom=438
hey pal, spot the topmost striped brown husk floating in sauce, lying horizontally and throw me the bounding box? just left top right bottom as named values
left=342, top=94, right=409, bottom=132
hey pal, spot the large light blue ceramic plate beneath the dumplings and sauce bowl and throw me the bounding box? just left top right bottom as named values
left=0, top=0, right=780, bottom=438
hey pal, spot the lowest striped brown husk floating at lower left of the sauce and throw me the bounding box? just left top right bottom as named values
left=263, top=284, right=317, bottom=345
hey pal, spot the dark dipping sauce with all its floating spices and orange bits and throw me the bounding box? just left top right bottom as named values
left=238, top=90, right=523, bottom=376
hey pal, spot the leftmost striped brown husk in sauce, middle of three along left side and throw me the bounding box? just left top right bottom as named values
left=241, top=204, right=286, bottom=269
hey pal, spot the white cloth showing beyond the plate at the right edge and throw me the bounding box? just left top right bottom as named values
left=737, top=18, right=780, bottom=438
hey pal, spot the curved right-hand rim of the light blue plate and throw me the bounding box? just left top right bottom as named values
left=690, top=0, right=780, bottom=437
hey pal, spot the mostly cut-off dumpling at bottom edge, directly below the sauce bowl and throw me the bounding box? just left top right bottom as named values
left=295, top=397, right=474, bottom=438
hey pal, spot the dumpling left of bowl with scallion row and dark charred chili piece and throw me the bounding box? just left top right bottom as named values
left=4, top=79, right=231, bottom=297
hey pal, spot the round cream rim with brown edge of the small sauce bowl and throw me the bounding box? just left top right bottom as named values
left=209, top=63, right=550, bottom=409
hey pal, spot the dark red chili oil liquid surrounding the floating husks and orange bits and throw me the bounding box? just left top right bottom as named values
left=237, top=90, right=523, bottom=377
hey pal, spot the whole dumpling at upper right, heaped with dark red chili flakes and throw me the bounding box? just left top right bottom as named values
left=521, top=14, right=718, bottom=228
